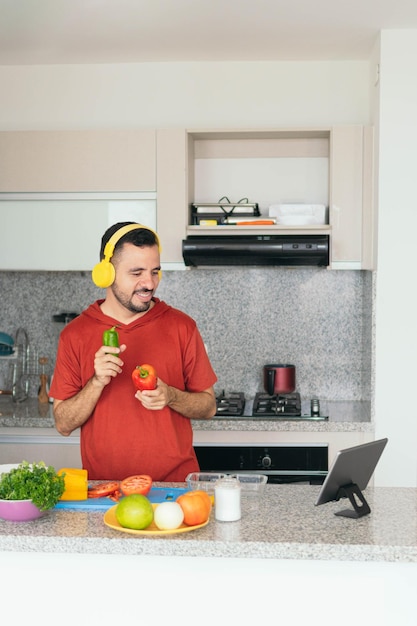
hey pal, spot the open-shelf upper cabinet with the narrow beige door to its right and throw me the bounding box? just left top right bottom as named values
left=184, top=126, right=375, bottom=269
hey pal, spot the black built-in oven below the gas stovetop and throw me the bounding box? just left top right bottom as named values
left=194, top=442, right=329, bottom=484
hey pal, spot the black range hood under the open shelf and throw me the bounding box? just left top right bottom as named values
left=182, top=235, right=329, bottom=267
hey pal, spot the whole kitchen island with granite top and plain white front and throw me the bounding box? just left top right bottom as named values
left=0, top=483, right=417, bottom=626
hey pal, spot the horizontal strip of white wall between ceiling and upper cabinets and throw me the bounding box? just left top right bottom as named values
left=0, top=62, right=369, bottom=130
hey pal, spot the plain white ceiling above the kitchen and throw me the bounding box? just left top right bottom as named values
left=0, top=0, right=417, bottom=65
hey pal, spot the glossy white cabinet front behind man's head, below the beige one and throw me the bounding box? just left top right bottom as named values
left=0, top=192, right=156, bottom=271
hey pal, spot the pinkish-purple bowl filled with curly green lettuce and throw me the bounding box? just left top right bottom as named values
left=0, top=461, right=65, bottom=522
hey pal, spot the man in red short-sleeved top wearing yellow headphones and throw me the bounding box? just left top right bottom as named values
left=50, top=222, right=217, bottom=481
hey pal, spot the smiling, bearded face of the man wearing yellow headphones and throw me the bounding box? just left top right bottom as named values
left=110, top=243, right=161, bottom=313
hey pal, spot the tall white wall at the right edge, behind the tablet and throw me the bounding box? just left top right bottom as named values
left=375, top=30, right=417, bottom=486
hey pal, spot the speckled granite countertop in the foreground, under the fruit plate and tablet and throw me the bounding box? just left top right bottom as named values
left=0, top=483, right=417, bottom=563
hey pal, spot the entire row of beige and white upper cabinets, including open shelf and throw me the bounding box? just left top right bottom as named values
left=0, top=126, right=376, bottom=270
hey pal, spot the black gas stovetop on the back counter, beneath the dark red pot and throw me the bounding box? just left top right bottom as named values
left=216, top=391, right=328, bottom=420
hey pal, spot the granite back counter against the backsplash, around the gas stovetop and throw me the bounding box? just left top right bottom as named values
left=0, top=397, right=374, bottom=432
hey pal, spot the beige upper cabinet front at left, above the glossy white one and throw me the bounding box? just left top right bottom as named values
left=0, top=129, right=156, bottom=193
